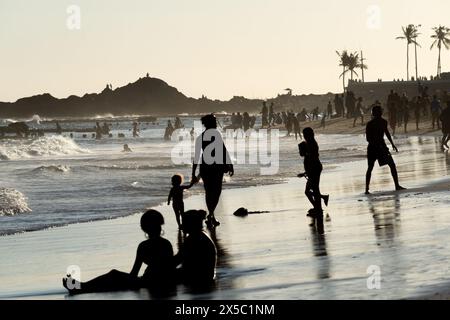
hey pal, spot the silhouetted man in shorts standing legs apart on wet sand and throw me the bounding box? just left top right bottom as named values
left=366, top=105, right=405, bottom=194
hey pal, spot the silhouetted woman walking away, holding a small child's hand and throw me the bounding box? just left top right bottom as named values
left=192, top=114, right=234, bottom=226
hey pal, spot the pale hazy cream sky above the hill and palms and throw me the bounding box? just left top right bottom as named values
left=0, top=0, right=450, bottom=101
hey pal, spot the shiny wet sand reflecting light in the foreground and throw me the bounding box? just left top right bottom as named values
left=0, top=137, right=450, bottom=300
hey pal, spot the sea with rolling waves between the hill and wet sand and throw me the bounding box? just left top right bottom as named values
left=0, top=115, right=390, bottom=236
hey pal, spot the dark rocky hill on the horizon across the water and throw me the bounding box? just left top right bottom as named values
left=0, top=76, right=333, bottom=118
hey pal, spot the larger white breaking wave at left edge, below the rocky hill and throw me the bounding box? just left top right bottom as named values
left=0, top=136, right=90, bottom=160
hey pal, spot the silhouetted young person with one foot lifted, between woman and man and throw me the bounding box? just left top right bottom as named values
left=298, top=128, right=329, bottom=216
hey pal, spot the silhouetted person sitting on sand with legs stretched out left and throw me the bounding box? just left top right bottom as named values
left=63, top=210, right=175, bottom=294
